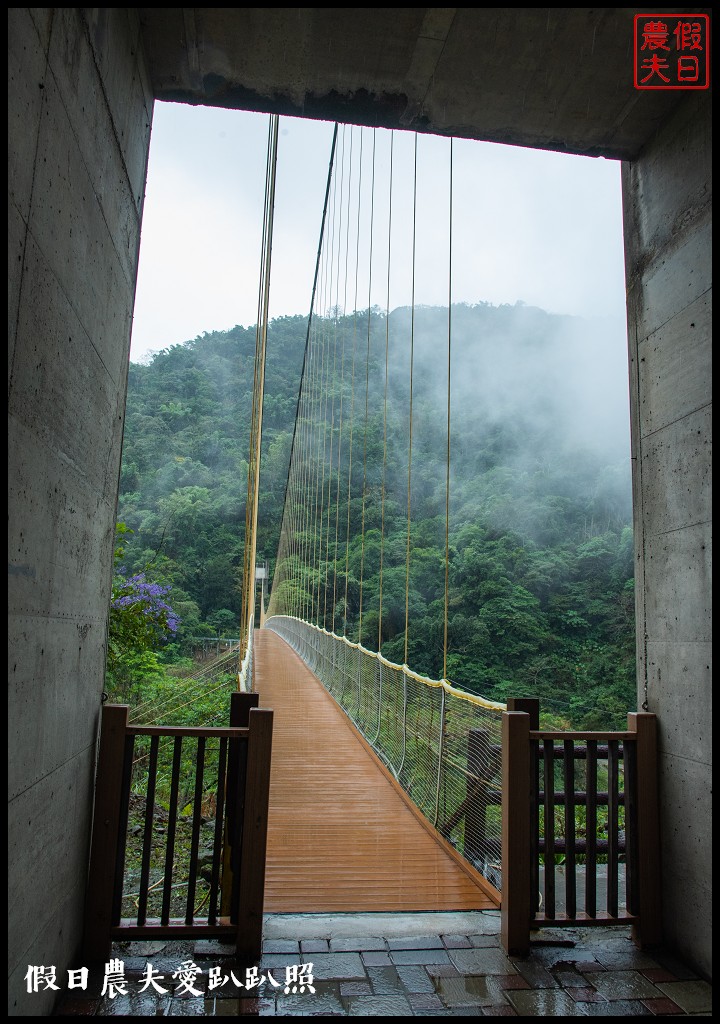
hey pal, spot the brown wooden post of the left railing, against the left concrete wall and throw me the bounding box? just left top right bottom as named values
left=83, top=705, right=128, bottom=964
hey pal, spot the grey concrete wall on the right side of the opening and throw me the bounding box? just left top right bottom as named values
left=624, top=94, right=713, bottom=977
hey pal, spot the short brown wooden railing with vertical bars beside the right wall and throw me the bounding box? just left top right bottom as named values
left=501, top=701, right=662, bottom=955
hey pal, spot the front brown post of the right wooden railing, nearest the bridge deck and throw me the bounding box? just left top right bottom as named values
left=500, top=712, right=532, bottom=956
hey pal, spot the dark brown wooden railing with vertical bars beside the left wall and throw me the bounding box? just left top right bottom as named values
left=84, top=693, right=272, bottom=963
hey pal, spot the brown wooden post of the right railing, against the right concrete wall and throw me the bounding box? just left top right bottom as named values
left=626, top=712, right=663, bottom=948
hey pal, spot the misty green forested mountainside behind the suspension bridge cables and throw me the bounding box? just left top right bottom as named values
left=118, top=303, right=635, bottom=727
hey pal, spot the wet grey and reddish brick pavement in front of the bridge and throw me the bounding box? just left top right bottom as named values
left=56, top=910, right=712, bottom=1017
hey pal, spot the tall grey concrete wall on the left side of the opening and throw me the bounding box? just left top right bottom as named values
left=8, top=7, right=153, bottom=1015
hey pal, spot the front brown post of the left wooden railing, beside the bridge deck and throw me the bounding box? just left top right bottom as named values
left=236, top=708, right=272, bottom=959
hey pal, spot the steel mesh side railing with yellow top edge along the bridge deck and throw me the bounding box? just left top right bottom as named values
left=265, top=615, right=505, bottom=890
